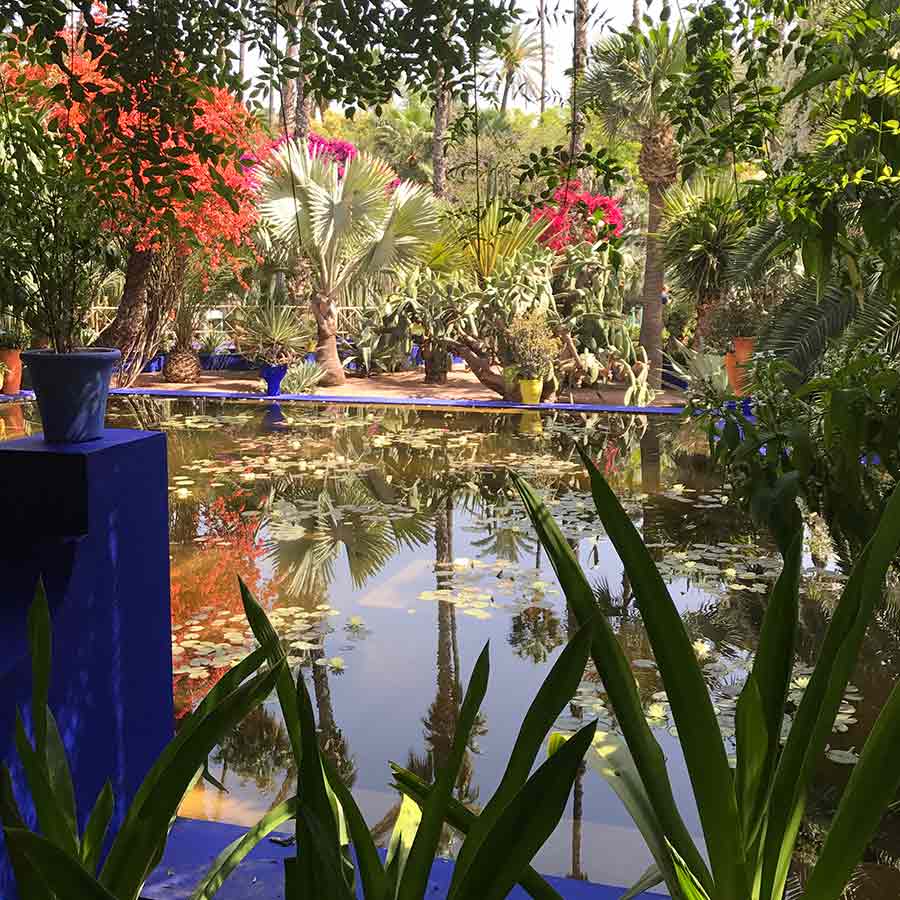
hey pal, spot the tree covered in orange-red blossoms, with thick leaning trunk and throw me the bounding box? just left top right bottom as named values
left=0, top=31, right=265, bottom=381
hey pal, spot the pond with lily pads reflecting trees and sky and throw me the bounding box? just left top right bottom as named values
left=0, top=398, right=900, bottom=900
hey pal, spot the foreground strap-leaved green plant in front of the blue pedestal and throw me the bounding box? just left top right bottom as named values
left=0, top=585, right=281, bottom=900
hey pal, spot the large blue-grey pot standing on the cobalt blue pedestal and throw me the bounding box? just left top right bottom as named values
left=22, top=348, right=122, bottom=444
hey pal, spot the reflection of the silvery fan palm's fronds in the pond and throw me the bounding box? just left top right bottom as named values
left=268, top=476, right=431, bottom=596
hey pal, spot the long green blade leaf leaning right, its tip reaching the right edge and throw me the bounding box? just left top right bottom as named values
left=761, top=489, right=900, bottom=896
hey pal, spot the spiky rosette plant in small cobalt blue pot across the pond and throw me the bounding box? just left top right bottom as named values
left=234, top=300, right=315, bottom=397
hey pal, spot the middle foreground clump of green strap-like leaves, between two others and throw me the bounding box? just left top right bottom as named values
left=191, top=584, right=596, bottom=900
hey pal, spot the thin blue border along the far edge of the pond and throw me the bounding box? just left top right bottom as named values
left=0, top=388, right=684, bottom=415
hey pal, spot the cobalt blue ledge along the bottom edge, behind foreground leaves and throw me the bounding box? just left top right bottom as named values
left=141, top=819, right=661, bottom=900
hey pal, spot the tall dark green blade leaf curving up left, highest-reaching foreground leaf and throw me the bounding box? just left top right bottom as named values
left=578, top=447, right=749, bottom=900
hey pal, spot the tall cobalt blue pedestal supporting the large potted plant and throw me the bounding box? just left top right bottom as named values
left=0, top=430, right=174, bottom=900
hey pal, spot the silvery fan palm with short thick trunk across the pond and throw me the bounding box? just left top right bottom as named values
left=259, top=140, right=439, bottom=385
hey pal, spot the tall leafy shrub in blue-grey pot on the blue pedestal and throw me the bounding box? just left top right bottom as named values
left=0, top=100, right=121, bottom=443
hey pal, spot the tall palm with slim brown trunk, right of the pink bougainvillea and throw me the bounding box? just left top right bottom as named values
left=579, top=22, right=685, bottom=387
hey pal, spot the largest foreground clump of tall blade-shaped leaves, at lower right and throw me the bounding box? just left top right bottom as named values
left=516, top=451, right=900, bottom=900
